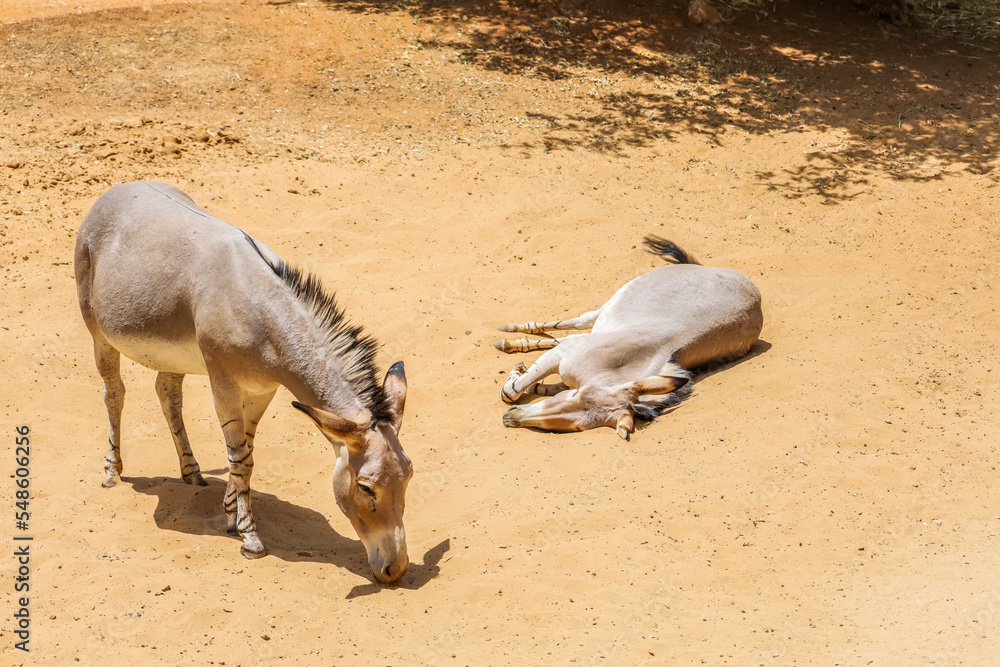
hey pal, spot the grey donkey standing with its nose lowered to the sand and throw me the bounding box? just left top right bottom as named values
left=74, top=182, right=413, bottom=583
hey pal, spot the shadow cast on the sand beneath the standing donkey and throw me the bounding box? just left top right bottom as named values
left=122, top=470, right=449, bottom=597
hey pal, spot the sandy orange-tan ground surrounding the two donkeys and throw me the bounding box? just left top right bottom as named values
left=0, top=0, right=1000, bottom=665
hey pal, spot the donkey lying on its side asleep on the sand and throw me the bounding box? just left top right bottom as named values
left=493, top=237, right=764, bottom=440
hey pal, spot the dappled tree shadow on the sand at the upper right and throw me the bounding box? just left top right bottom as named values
left=323, top=0, right=1000, bottom=198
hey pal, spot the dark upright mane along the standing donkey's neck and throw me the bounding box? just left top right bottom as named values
left=270, top=258, right=390, bottom=421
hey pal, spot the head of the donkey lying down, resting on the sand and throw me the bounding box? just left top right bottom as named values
left=503, top=375, right=688, bottom=440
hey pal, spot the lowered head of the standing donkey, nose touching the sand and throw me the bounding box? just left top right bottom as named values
left=292, top=363, right=413, bottom=583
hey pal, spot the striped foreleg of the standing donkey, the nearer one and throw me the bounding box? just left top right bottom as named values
left=209, top=378, right=267, bottom=558
